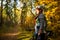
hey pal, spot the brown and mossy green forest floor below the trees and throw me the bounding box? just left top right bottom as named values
left=0, top=24, right=60, bottom=40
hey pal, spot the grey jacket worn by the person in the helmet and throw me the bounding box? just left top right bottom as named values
left=35, top=13, right=47, bottom=33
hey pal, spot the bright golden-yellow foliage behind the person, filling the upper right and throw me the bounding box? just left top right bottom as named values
left=36, top=0, right=59, bottom=30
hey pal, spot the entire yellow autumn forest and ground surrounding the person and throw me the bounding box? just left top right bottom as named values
left=0, top=0, right=60, bottom=40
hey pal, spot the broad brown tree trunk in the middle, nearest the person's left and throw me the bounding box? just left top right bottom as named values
left=20, top=0, right=28, bottom=26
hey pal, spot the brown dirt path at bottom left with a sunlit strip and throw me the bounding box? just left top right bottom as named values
left=0, top=33, right=20, bottom=40
